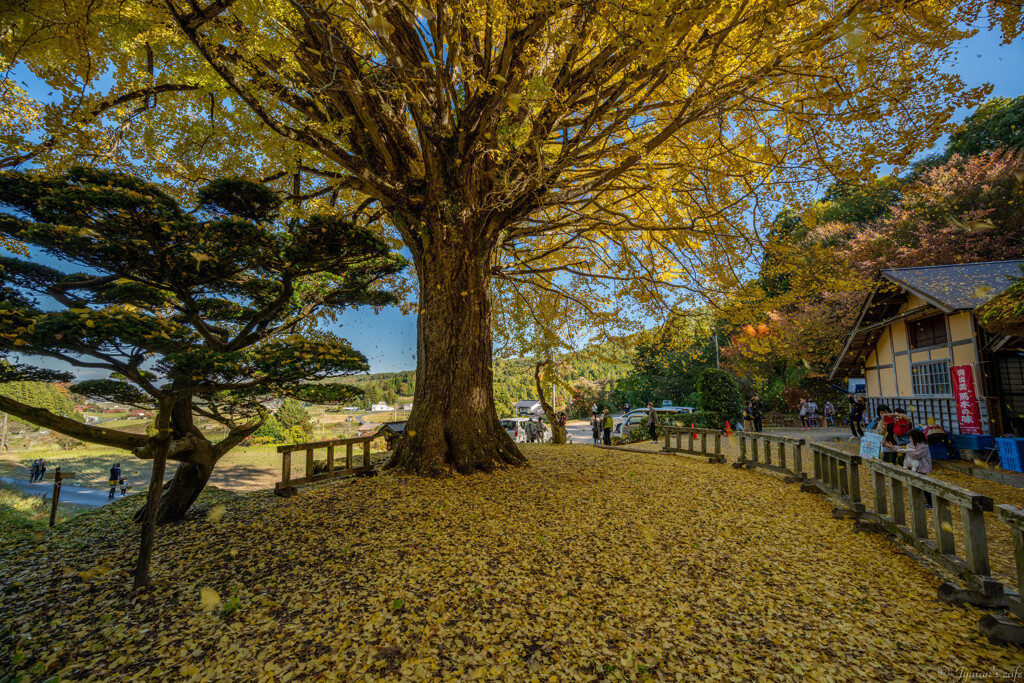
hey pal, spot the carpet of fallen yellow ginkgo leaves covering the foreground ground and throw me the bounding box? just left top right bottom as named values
left=0, top=445, right=1024, bottom=681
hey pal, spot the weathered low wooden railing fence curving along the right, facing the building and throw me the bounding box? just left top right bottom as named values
left=665, top=427, right=1024, bottom=643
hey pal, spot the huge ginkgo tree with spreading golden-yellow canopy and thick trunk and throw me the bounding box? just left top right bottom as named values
left=2, top=0, right=1020, bottom=473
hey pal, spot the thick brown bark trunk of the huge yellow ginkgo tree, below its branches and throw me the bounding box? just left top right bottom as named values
left=388, top=241, right=526, bottom=476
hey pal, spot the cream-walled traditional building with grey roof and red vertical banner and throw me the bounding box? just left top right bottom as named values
left=829, top=261, right=1024, bottom=434
